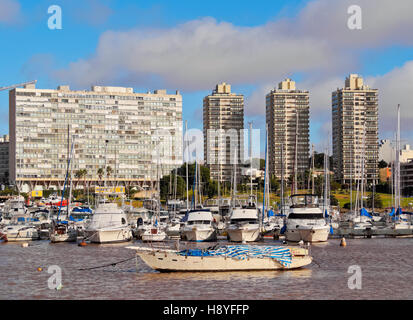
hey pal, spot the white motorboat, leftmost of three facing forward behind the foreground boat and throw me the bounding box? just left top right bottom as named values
left=182, top=209, right=217, bottom=242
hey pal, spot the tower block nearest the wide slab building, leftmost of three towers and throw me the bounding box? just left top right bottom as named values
left=203, top=82, right=244, bottom=182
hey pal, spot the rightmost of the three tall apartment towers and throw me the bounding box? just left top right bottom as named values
left=332, top=74, right=379, bottom=183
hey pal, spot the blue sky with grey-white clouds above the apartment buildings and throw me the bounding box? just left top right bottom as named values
left=0, top=0, right=413, bottom=158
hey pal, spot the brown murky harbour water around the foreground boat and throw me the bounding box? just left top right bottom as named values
left=0, top=238, right=413, bottom=300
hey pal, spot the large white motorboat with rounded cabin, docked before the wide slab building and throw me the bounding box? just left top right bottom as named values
left=84, top=203, right=132, bottom=243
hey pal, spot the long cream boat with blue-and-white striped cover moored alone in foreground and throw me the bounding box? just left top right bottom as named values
left=127, top=245, right=312, bottom=272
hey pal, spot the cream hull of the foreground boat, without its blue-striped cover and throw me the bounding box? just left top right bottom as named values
left=136, top=251, right=312, bottom=272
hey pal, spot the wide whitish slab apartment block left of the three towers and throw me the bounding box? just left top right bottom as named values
left=9, top=85, right=182, bottom=189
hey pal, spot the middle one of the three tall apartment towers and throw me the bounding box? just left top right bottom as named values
left=266, top=79, right=310, bottom=179
